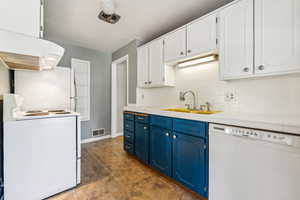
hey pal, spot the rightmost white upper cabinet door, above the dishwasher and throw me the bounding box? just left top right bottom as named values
left=255, top=0, right=300, bottom=74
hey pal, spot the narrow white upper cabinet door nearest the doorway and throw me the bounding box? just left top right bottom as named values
left=137, top=46, right=149, bottom=87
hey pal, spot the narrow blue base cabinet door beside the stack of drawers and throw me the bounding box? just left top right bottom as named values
left=135, top=123, right=149, bottom=164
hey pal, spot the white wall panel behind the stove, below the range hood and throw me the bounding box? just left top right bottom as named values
left=15, top=67, right=71, bottom=110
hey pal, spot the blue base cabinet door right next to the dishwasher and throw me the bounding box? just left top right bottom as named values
left=173, top=132, right=208, bottom=198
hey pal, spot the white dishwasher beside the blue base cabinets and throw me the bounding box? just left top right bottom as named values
left=209, top=124, right=300, bottom=200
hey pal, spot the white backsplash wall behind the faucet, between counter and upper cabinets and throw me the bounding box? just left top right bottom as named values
left=137, top=62, right=300, bottom=115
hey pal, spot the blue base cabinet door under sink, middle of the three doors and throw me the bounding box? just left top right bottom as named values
left=150, top=126, right=172, bottom=176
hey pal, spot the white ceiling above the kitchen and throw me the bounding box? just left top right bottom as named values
left=45, top=0, right=232, bottom=52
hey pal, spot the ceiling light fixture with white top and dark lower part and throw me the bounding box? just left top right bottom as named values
left=98, top=0, right=121, bottom=24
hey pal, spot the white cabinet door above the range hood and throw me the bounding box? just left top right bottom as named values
left=0, top=0, right=41, bottom=38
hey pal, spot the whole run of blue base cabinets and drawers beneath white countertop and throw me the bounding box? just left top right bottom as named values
left=124, top=112, right=208, bottom=198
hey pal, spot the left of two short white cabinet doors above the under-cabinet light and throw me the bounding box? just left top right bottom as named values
left=165, top=28, right=186, bottom=62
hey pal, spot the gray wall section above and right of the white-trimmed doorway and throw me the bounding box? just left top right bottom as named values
left=112, top=40, right=138, bottom=104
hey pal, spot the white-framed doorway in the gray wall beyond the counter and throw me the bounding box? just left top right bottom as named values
left=111, top=55, right=129, bottom=137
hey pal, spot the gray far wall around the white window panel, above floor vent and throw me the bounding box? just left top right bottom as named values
left=46, top=38, right=111, bottom=139
